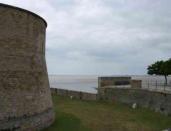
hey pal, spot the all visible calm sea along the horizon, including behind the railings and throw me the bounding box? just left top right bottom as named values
left=49, top=75, right=171, bottom=94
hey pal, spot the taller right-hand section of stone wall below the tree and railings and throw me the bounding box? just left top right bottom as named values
left=98, top=87, right=171, bottom=115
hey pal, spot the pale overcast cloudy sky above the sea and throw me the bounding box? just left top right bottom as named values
left=0, top=0, right=171, bottom=75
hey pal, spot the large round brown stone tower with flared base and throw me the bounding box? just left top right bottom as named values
left=0, top=3, right=54, bottom=131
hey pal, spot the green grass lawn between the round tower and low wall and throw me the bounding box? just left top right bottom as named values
left=43, top=96, right=171, bottom=131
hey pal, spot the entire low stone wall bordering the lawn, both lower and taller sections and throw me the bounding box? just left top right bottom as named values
left=51, top=87, right=171, bottom=115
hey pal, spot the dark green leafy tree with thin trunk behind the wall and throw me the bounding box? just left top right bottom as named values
left=147, top=58, right=171, bottom=85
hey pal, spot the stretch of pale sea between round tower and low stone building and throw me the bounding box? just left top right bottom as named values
left=49, top=75, right=98, bottom=94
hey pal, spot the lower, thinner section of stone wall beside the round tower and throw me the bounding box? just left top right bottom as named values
left=51, top=88, right=97, bottom=101
